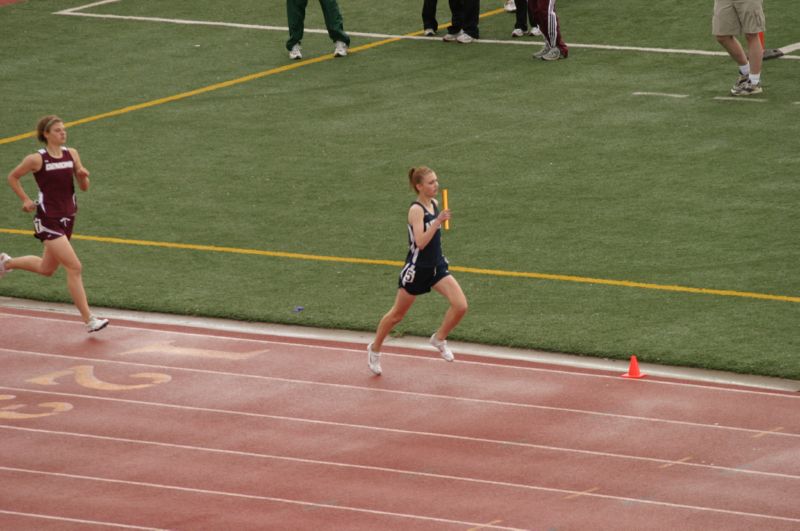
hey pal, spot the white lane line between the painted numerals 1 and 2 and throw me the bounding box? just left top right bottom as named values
left=6, top=348, right=800, bottom=438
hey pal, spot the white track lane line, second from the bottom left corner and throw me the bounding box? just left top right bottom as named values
left=0, top=466, right=524, bottom=531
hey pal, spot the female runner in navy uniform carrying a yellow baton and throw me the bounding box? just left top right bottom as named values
left=367, top=166, right=467, bottom=374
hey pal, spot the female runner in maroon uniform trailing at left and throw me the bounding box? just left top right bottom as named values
left=0, top=116, right=108, bottom=332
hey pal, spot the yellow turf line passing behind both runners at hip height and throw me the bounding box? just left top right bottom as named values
left=0, top=229, right=800, bottom=303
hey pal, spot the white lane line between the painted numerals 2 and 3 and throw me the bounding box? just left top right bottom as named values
left=0, top=387, right=800, bottom=480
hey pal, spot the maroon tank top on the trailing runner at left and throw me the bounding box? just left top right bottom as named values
left=33, top=147, right=78, bottom=218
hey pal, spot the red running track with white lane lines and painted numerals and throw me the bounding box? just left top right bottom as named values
left=0, top=308, right=800, bottom=531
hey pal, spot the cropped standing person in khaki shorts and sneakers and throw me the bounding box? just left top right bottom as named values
left=711, top=0, right=766, bottom=96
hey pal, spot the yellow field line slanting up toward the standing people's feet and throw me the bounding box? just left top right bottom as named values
left=0, top=8, right=503, bottom=145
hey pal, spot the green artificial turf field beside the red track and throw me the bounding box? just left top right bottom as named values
left=0, top=0, right=800, bottom=379
